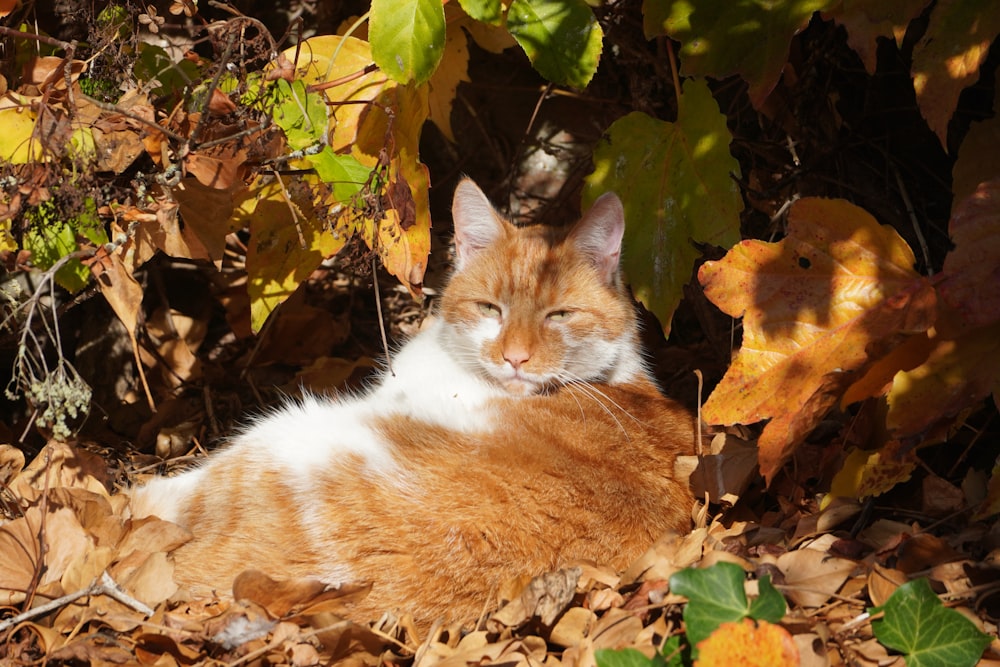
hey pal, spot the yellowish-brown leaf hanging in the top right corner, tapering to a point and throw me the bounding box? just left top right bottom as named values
left=911, top=0, right=1000, bottom=150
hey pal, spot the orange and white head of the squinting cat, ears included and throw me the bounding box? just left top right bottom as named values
left=440, top=179, right=642, bottom=394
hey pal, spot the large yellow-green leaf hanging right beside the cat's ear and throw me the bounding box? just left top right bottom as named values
left=584, top=81, right=743, bottom=333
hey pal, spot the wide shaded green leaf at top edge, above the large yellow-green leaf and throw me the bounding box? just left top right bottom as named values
left=643, top=0, right=838, bottom=108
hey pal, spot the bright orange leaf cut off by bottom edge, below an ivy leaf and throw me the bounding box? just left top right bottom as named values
left=694, top=618, right=799, bottom=667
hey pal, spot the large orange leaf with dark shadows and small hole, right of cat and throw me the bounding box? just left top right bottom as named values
left=698, top=198, right=935, bottom=481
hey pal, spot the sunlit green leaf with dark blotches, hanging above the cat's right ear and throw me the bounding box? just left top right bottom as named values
left=507, top=0, right=604, bottom=89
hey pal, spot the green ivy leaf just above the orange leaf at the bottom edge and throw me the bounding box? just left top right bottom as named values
left=670, top=562, right=786, bottom=645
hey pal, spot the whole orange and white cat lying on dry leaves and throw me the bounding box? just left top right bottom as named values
left=132, top=180, right=694, bottom=623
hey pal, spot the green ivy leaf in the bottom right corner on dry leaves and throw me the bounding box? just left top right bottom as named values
left=869, top=579, right=991, bottom=667
